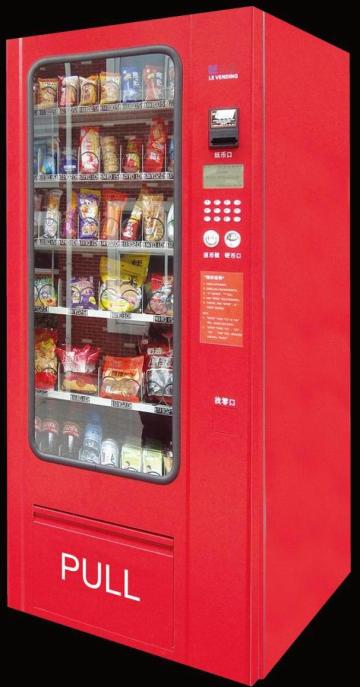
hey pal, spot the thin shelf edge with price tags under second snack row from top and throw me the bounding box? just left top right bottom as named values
left=34, top=172, right=174, bottom=188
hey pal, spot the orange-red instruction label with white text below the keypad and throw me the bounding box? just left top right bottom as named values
left=200, top=272, right=244, bottom=346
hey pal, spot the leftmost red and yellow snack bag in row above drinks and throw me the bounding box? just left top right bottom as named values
left=35, top=328, right=58, bottom=390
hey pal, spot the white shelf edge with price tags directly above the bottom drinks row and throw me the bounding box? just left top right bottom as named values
left=35, top=389, right=172, bottom=416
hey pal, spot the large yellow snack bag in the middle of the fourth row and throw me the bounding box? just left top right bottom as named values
left=99, top=255, right=150, bottom=312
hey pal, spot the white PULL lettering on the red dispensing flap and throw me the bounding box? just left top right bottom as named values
left=61, top=552, right=141, bottom=601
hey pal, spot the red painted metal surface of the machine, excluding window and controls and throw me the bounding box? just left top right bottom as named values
left=7, top=8, right=348, bottom=684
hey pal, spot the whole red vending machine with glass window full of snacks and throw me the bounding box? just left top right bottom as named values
left=7, top=7, right=350, bottom=684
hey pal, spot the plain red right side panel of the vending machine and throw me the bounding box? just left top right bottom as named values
left=264, top=15, right=350, bottom=674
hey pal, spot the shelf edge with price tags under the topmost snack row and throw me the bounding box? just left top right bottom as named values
left=34, top=99, right=174, bottom=121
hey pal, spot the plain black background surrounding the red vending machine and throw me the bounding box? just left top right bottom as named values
left=0, top=0, right=359, bottom=687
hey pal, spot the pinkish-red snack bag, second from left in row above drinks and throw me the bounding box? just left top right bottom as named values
left=56, top=344, right=101, bottom=394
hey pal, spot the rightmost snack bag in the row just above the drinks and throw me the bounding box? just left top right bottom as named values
left=144, top=340, right=174, bottom=405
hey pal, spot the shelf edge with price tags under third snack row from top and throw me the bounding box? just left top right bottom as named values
left=34, top=238, right=174, bottom=256
